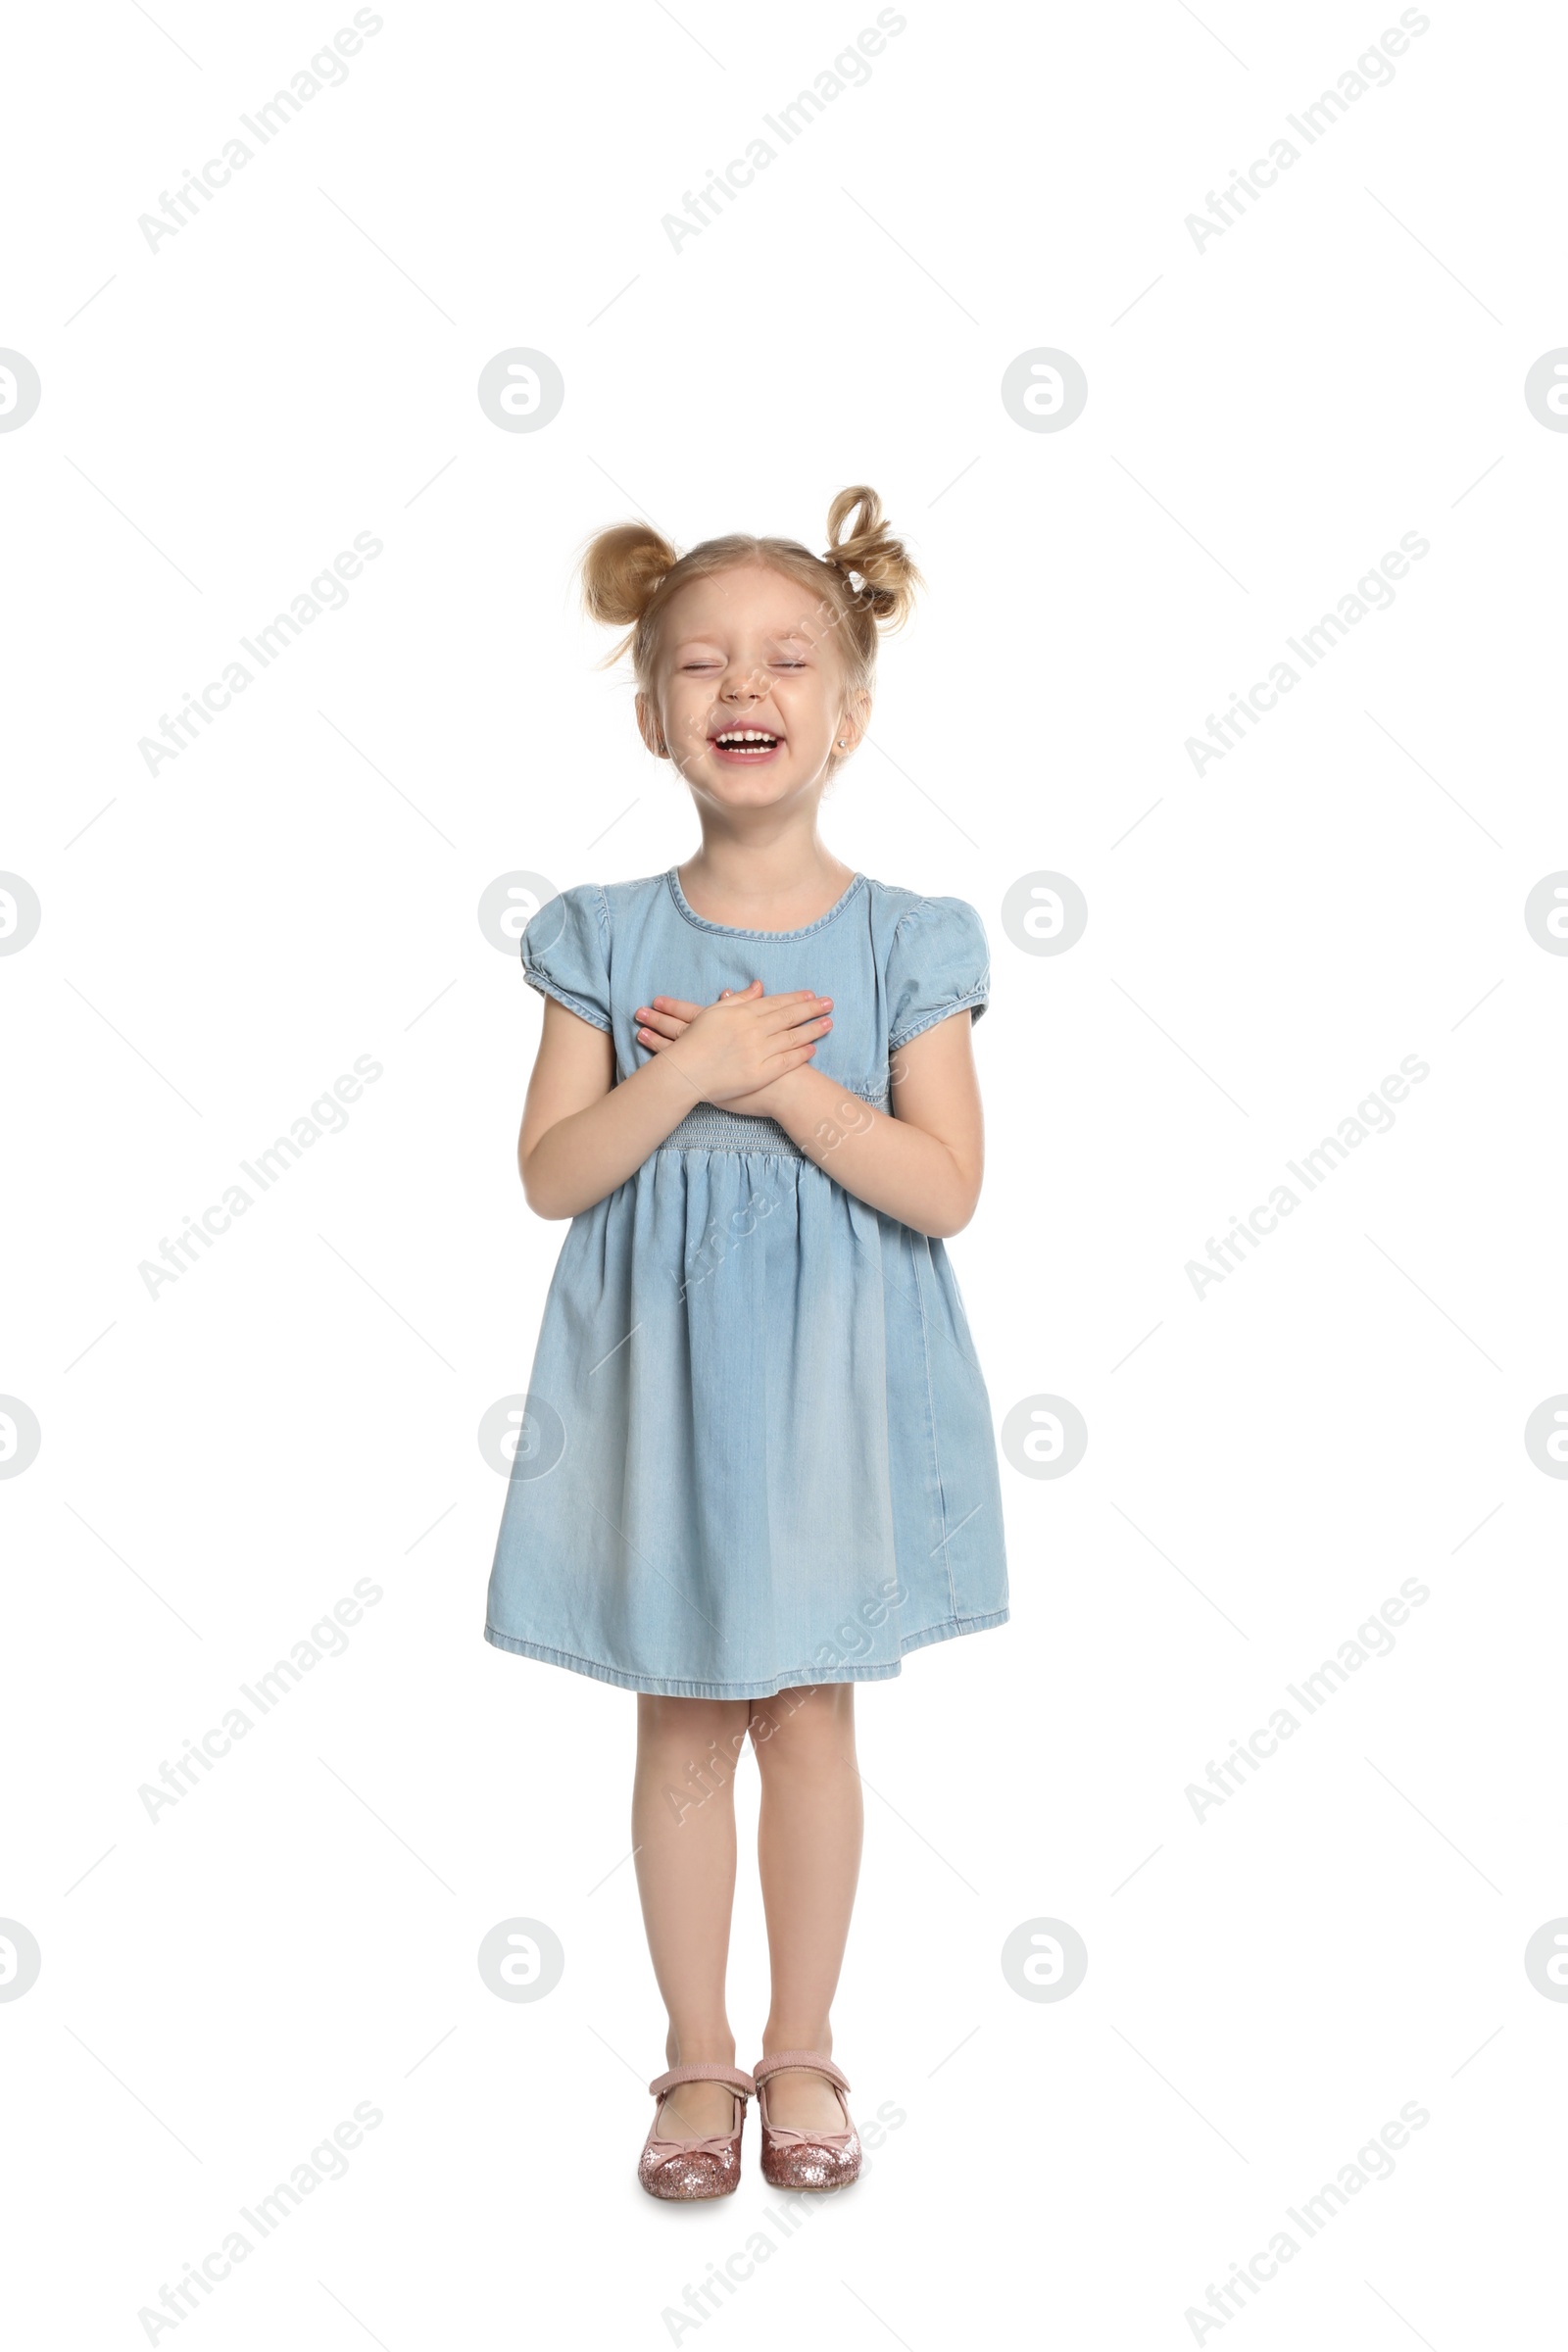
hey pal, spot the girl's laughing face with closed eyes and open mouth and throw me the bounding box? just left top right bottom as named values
left=637, top=564, right=870, bottom=809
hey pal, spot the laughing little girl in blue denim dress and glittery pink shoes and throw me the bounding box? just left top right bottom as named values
left=484, top=487, right=1008, bottom=2199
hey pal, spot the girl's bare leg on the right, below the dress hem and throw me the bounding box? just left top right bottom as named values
left=750, top=1682, right=862, bottom=2131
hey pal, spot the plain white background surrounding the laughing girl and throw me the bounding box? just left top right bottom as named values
left=0, top=0, right=1568, bottom=2352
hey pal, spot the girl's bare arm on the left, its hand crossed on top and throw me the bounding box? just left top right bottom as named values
left=517, top=988, right=837, bottom=1218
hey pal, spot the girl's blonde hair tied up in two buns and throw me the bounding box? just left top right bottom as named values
left=581, top=482, right=926, bottom=753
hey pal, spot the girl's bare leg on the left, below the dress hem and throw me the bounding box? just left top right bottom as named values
left=632, top=1691, right=750, bottom=2140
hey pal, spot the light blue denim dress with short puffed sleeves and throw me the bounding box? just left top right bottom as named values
left=484, top=868, right=1008, bottom=1698
